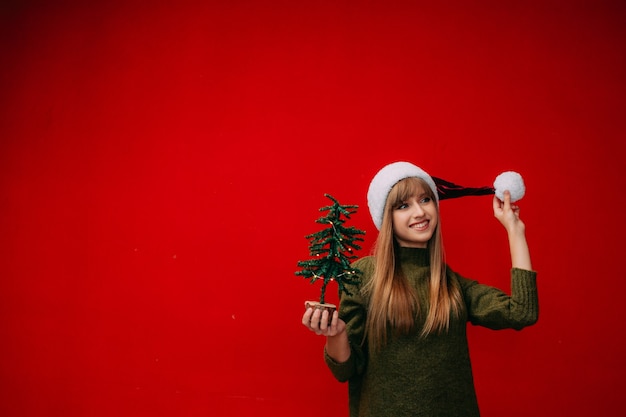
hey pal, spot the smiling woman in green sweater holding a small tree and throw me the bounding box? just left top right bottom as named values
left=302, top=162, right=538, bottom=417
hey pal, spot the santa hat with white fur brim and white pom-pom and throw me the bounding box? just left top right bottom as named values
left=367, top=162, right=526, bottom=230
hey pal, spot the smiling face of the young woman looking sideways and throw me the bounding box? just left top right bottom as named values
left=393, top=185, right=439, bottom=248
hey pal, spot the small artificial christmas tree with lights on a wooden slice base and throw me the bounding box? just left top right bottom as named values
left=296, top=194, right=365, bottom=318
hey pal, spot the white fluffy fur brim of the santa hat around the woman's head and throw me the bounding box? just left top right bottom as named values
left=367, top=162, right=439, bottom=230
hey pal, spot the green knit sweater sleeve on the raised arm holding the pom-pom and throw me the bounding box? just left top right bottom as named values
left=457, top=268, right=539, bottom=330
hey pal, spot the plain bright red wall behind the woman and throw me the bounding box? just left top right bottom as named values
left=0, top=0, right=626, bottom=417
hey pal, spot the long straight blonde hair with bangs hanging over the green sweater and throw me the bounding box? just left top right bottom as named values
left=364, top=177, right=462, bottom=349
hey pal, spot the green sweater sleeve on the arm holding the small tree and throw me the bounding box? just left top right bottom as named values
left=324, top=258, right=372, bottom=382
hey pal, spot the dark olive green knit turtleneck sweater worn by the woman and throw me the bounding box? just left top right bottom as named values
left=325, top=248, right=539, bottom=417
